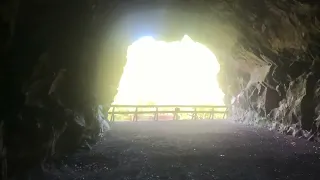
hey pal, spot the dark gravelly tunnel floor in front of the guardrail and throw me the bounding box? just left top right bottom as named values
left=38, top=120, right=320, bottom=180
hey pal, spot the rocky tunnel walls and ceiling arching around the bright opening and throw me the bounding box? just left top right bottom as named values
left=0, top=0, right=320, bottom=179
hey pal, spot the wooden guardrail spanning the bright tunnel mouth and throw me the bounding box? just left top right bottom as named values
left=108, top=105, right=228, bottom=121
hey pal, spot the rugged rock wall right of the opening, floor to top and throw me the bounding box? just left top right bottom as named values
left=221, top=1, right=320, bottom=141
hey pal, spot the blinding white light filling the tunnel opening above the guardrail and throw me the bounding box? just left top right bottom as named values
left=113, top=35, right=224, bottom=105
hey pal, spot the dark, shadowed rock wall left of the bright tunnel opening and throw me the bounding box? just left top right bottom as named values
left=0, top=0, right=113, bottom=179
